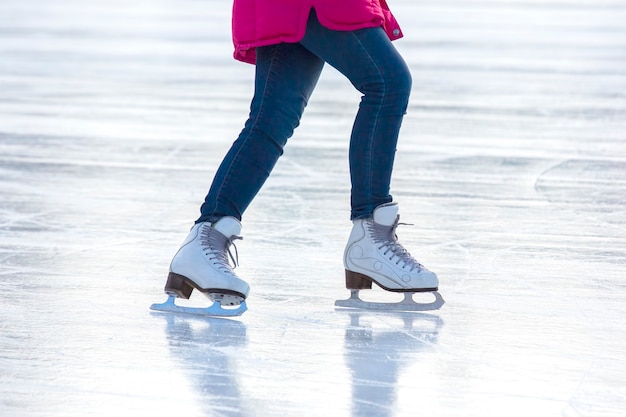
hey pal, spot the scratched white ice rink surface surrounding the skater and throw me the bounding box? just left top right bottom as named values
left=0, top=0, right=626, bottom=417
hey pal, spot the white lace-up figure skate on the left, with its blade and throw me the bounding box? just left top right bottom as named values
left=150, top=217, right=250, bottom=316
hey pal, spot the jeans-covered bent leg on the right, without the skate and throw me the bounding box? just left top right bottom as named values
left=300, top=12, right=411, bottom=220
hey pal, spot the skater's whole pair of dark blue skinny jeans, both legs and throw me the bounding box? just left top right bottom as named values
left=197, top=12, right=411, bottom=222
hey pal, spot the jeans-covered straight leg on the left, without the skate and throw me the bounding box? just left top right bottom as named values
left=196, top=43, right=324, bottom=223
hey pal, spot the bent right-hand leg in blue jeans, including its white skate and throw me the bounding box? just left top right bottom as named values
left=294, top=13, right=439, bottom=294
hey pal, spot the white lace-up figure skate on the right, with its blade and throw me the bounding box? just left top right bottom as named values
left=335, top=203, right=444, bottom=311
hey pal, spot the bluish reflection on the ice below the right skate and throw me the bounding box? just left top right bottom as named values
left=345, top=311, right=443, bottom=417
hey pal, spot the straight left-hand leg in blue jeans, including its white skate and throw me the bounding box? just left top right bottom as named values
left=158, top=44, right=323, bottom=315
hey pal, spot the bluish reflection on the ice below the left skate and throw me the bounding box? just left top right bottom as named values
left=153, top=313, right=248, bottom=417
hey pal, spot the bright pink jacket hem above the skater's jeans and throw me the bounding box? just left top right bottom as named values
left=233, top=0, right=402, bottom=64
